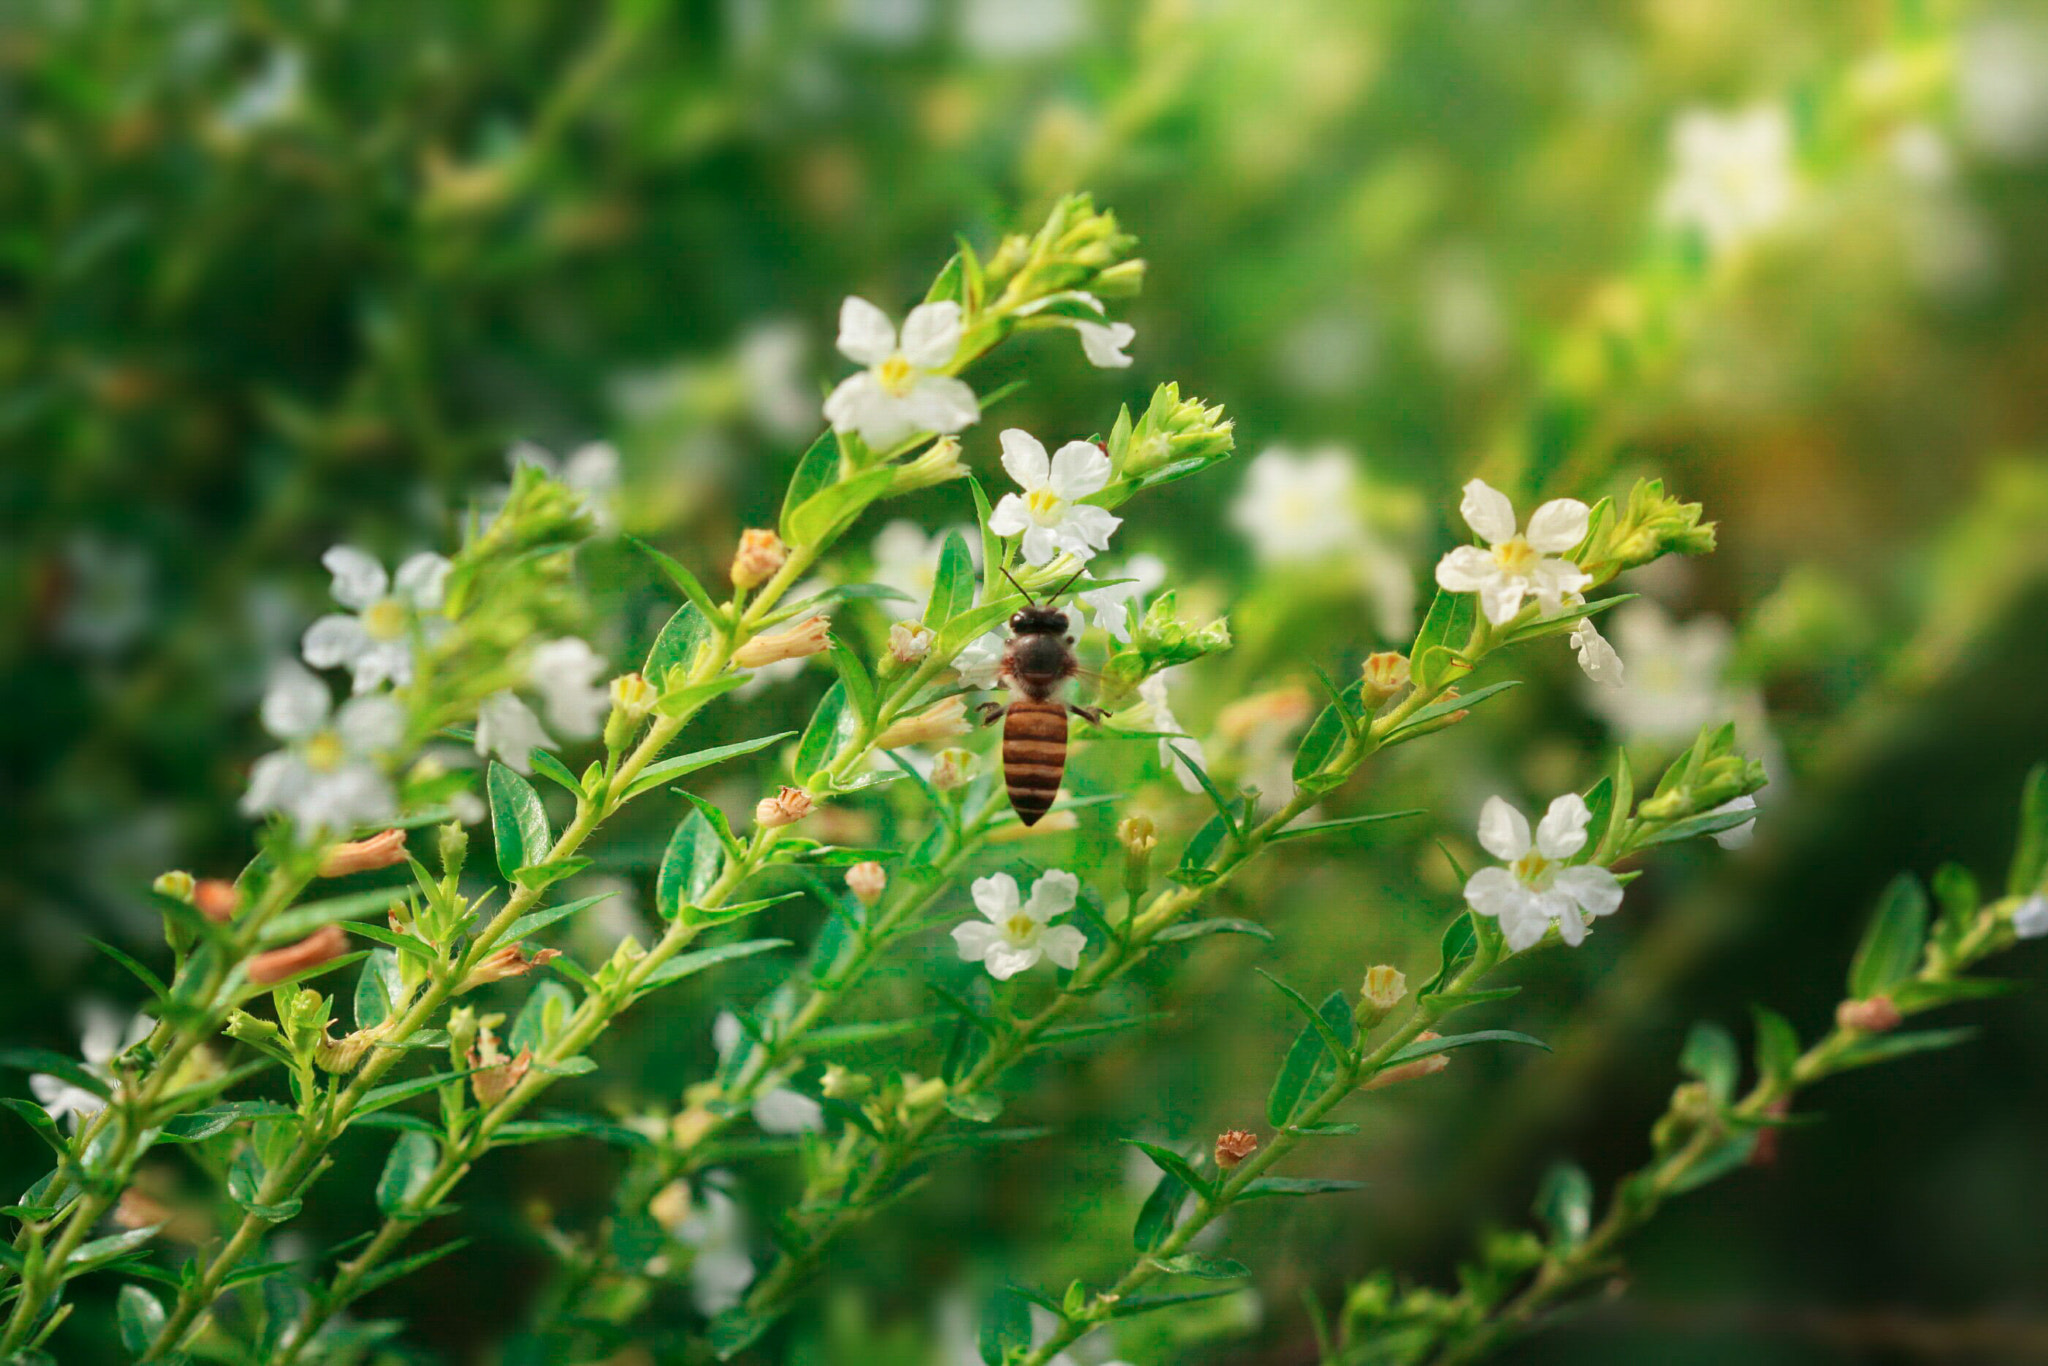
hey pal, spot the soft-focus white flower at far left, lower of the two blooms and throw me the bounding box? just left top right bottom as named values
left=242, top=661, right=406, bottom=834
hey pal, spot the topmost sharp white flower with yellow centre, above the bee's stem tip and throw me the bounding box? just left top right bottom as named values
left=825, top=297, right=981, bottom=451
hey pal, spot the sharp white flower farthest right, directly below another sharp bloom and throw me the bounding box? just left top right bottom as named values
left=1464, top=793, right=1622, bottom=952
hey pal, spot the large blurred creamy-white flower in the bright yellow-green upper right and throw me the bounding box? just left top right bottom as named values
left=1659, top=104, right=1796, bottom=252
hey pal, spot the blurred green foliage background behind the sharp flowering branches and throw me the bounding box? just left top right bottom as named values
left=0, top=0, right=2048, bottom=1366
